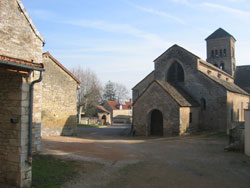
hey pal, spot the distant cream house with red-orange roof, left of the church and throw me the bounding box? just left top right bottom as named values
left=102, top=101, right=132, bottom=124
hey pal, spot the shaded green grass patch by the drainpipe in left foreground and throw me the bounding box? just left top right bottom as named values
left=32, top=155, right=77, bottom=188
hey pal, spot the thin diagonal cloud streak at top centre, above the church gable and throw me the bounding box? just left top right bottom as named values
left=134, top=5, right=186, bottom=24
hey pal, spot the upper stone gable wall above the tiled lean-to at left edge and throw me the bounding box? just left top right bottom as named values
left=0, top=0, right=43, bottom=63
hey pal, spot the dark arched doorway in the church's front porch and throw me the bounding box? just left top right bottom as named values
left=150, top=110, right=163, bottom=136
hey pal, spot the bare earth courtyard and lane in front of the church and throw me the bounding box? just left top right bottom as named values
left=42, top=126, right=250, bottom=188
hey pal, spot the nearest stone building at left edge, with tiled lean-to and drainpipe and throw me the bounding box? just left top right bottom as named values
left=0, top=0, right=44, bottom=187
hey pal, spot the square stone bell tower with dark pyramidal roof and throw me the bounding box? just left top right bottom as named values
left=205, top=28, right=236, bottom=77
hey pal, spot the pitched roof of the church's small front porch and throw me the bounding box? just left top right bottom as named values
left=134, top=80, right=199, bottom=107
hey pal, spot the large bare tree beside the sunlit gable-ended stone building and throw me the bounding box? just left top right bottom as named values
left=72, top=66, right=102, bottom=119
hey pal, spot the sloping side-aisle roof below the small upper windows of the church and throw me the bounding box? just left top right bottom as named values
left=201, top=72, right=249, bottom=95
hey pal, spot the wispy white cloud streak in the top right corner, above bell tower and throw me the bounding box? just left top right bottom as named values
left=201, top=3, right=250, bottom=17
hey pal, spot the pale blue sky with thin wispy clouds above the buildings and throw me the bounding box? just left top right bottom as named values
left=22, top=0, right=250, bottom=95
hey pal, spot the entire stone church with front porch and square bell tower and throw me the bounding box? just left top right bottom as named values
left=133, top=28, right=250, bottom=136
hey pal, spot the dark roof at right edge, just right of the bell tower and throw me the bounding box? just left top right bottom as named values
left=235, top=65, right=250, bottom=92
